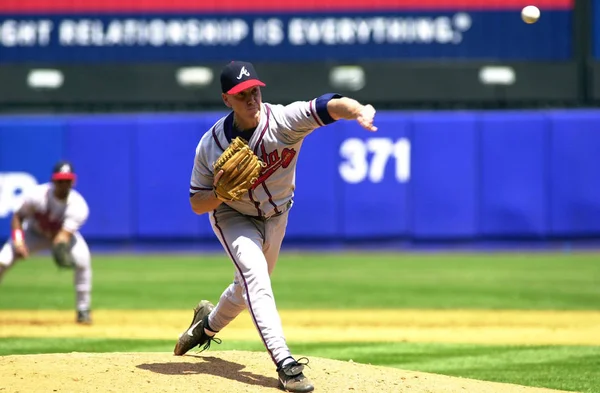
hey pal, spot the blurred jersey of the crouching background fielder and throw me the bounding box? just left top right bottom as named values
left=15, top=183, right=89, bottom=239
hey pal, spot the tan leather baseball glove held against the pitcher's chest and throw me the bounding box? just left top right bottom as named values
left=213, top=137, right=266, bottom=201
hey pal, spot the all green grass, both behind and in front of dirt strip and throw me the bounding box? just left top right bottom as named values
left=0, top=253, right=600, bottom=393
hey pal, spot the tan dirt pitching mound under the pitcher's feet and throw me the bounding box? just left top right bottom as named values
left=0, top=351, right=572, bottom=393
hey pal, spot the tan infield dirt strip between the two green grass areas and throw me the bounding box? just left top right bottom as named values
left=0, top=310, right=600, bottom=345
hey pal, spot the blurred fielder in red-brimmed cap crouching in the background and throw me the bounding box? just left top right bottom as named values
left=0, top=161, right=92, bottom=324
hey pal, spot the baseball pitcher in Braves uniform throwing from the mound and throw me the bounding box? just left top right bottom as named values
left=174, top=61, right=377, bottom=392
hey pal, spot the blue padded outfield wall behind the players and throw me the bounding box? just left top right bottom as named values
left=0, top=110, right=600, bottom=241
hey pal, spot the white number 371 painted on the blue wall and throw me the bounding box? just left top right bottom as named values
left=339, top=138, right=410, bottom=184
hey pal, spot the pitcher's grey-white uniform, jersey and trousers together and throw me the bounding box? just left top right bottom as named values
left=190, top=94, right=340, bottom=364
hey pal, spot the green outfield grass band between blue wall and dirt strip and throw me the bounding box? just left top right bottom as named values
left=0, top=253, right=600, bottom=311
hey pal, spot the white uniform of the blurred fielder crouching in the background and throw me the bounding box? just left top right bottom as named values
left=0, top=183, right=92, bottom=310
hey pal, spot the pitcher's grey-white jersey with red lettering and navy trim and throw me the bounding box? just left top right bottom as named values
left=190, top=94, right=341, bottom=217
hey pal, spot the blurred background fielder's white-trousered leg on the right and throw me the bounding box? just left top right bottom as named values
left=71, top=232, right=92, bottom=323
